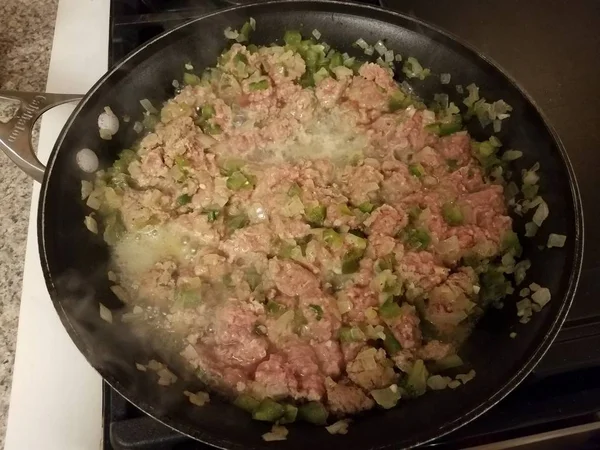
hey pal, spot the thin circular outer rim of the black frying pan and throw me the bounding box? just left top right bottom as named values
left=37, top=0, right=584, bottom=449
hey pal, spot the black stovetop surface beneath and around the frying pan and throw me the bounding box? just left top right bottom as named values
left=104, top=0, right=600, bottom=450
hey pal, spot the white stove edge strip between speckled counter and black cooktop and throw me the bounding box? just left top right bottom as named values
left=4, top=0, right=110, bottom=450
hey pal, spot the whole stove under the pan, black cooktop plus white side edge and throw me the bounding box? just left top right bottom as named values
left=5, top=0, right=600, bottom=450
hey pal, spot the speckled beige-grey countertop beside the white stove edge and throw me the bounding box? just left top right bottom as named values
left=0, top=0, right=58, bottom=442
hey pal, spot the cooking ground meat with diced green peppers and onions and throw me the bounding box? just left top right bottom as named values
left=85, top=23, right=564, bottom=438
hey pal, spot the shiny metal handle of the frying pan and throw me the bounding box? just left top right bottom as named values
left=0, top=91, right=82, bottom=183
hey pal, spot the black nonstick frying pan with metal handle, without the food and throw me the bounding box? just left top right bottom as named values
left=0, top=1, right=583, bottom=449
